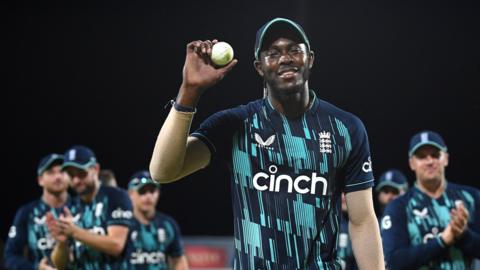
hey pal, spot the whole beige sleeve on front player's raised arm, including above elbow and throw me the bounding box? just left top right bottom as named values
left=150, top=107, right=211, bottom=183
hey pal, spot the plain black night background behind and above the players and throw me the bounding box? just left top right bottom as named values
left=4, top=0, right=480, bottom=239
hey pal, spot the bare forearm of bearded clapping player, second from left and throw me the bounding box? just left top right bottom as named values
left=72, top=227, right=125, bottom=256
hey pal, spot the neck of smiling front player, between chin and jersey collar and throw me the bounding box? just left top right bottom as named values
left=268, top=83, right=311, bottom=119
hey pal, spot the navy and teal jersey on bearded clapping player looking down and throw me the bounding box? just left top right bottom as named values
left=67, top=185, right=133, bottom=270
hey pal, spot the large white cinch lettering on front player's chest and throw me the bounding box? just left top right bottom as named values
left=253, top=165, right=328, bottom=195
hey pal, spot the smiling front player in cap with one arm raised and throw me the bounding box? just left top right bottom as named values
left=150, top=18, right=383, bottom=270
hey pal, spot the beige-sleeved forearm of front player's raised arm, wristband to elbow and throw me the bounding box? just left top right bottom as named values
left=150, top=108, right=193, bottom=183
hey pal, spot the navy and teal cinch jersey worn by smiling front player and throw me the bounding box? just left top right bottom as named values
left=192, top=91, right=374, bottom=269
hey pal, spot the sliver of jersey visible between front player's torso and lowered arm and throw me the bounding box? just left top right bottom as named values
left=338, top=213, right=358, bottom=270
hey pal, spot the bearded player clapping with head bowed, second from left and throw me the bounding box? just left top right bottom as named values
left=48, top=146, right=133, bottom=270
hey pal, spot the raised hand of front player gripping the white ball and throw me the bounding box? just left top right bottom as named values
left=182, top=40, right=238, bottom=94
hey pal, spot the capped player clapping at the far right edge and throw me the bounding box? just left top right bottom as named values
left=381, top=131, right=480, bottom=270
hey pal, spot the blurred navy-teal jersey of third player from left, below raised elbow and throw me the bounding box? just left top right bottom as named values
left=126, top=212, right=183, bottom=270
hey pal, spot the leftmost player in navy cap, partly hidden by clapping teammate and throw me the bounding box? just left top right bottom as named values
left=4, top=154, right=69, bottom=269
